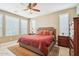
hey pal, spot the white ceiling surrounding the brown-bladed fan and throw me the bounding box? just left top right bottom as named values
left=0, top=3, right=77, bottom=18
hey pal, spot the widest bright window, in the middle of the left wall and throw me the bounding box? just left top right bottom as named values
left=5, top=16, right=19, bottom=36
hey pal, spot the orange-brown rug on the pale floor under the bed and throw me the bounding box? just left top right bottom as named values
left=8, top=45, right=59, bottom=56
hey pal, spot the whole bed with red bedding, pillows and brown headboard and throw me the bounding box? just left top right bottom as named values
left=18, top=27, right=56, bottom=55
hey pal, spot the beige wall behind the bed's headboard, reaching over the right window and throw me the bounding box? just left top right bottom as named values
left=31, top=7, right=76, bottom=39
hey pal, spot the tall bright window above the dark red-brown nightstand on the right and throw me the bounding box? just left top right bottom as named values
left=59, top=13, right=69, bottom=36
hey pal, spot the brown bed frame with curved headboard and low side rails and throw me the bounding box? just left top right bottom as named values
left=19, top=27, right=56, bottom=55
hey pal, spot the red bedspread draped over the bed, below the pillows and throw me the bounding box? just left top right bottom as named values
left=18, top=35, right=53, bottom=55
